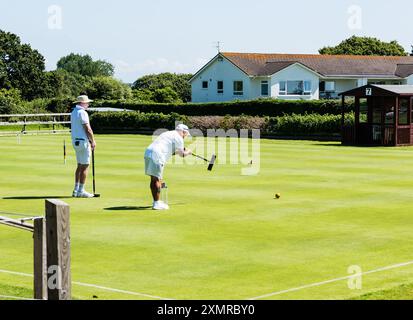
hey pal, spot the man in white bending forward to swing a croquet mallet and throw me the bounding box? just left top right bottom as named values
left=145, top=124, right=192, bottom=210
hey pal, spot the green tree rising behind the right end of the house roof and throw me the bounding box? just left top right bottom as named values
left=319, top=36, right=407, bottom=56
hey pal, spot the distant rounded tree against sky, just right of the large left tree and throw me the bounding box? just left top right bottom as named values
left=57, top=53, right=115, bottom=77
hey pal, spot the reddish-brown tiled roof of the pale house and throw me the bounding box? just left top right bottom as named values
left=221, top=52, right=413, bottom=78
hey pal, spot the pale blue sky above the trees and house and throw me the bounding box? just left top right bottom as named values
left=0, top=0, right=413, bottom=82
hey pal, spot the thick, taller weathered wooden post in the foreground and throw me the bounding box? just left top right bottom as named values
left=46, top=200, right=72, bottom=300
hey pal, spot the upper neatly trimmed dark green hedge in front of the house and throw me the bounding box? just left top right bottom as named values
left=93, top=99, right=354, bottom=117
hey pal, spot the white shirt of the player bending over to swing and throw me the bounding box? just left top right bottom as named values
left=145, top=130, right=184, bottom=164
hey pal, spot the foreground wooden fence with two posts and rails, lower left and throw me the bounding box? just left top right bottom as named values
left=0, top=200, right=72, bottom=300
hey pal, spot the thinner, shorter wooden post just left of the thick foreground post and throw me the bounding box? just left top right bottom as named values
left=33, top=218, right=47, bottom=300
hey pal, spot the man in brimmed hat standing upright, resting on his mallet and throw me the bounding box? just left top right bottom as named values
left=71, top=95, right=96, bottom=198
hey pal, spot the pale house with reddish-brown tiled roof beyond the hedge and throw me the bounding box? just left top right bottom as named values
left=190, top=52, right=413, bottom=102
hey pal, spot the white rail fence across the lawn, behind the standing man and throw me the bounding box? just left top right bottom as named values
left=0, top=113, right=70, bottom=135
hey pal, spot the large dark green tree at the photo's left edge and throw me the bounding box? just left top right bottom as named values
left=0, top=30, right=45, bottom=100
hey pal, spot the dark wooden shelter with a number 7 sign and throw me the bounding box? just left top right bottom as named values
left=340, top=85, right=413, bottom=146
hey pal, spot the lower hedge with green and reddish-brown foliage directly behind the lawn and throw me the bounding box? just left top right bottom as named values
left=91, top=112, right=354, bottom=136
